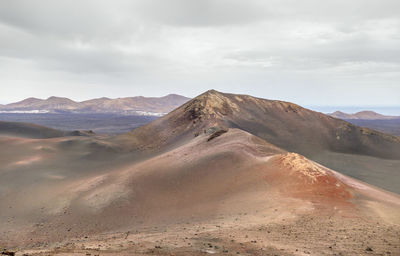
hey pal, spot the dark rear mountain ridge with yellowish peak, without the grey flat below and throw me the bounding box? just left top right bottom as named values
left=123, top=90, right=400, bottom=159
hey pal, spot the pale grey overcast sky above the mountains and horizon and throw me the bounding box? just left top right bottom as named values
left=0, top=0, right=400, bottom=109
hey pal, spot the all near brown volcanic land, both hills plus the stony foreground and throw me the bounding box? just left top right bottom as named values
left=0, top=90, right=400, bottom=255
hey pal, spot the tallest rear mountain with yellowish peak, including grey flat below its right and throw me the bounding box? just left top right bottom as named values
left=121, top=90, right=400, bottom=193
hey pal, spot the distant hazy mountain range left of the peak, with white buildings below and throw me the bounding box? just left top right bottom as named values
left=0, top=94, right=190, bottom=116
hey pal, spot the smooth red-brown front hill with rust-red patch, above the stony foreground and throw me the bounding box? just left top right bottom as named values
left=0, top=129, right=400, bottom=249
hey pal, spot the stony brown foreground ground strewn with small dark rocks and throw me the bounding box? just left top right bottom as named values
left=3, top=207, right=400, bottom=256
